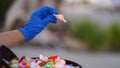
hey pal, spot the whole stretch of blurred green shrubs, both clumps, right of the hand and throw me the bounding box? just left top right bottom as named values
left=70, top=19, right=120, bottom=51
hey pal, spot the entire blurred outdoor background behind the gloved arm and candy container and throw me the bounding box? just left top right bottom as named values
left=0, top=0, right=120, bottom=68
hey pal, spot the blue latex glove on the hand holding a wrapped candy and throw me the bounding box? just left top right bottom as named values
left=19, top=6, right=58, bottom=41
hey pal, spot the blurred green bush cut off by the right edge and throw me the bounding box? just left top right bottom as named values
left=108, top=21, right=120, bottom=51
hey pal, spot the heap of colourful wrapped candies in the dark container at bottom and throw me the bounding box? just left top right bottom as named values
left=10, top=55, right=79, bottom=68
